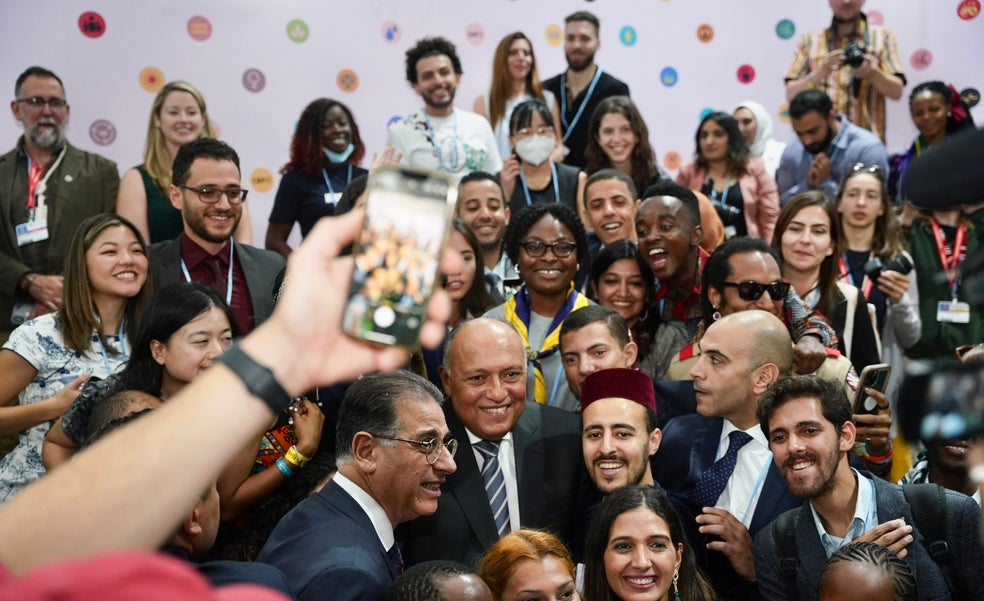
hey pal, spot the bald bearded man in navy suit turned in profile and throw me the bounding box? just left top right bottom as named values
left=653, top=310, right=799, bottom=599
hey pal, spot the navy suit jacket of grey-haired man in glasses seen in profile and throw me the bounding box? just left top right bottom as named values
left=256, top=482, right=397, bottom=601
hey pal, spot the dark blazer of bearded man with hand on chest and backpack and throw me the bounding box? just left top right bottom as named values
left=755, top=472, right=984, bottom=601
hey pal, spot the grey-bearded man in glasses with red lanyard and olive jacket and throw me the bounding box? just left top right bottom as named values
left=0, top=67, right=120, bottom=341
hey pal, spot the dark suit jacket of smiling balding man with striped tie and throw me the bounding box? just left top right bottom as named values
left=397, top=399, right=597, bottom=566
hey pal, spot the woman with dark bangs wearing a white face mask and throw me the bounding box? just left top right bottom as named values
left=499, top=100, right=587, bottom=221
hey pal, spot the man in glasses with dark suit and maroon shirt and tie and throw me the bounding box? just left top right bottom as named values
left=150, top=138, right=286, bottom=336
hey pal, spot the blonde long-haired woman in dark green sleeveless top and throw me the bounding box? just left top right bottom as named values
left=116, top=81, right=253, bottom=244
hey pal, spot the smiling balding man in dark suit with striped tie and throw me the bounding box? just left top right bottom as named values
left=400, top=319, right=593, bottom=565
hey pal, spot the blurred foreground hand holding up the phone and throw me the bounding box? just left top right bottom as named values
left=241, top=211, right=454, bottom=396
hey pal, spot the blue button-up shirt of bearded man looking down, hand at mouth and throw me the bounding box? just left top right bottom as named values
left=776, top=115, right=888, bottom=205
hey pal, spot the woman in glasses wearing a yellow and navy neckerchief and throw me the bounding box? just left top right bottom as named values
left=485, top=203, right=591, bottom=411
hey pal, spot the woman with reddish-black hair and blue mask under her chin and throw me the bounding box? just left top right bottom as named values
left=266, top=98, right=367, bottom=257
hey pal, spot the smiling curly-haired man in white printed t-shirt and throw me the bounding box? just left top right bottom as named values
left=386, top=38, right=502, bottom=178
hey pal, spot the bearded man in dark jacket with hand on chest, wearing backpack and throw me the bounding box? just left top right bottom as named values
left=755, top=376, right=984, bottom=601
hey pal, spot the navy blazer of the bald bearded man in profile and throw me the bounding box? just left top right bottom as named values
left=652, top=413, right=801, bottom=599
